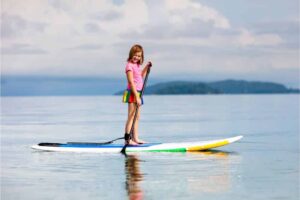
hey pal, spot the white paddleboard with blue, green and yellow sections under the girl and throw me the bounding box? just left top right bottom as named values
left=32, top=136, right=243, bottom=153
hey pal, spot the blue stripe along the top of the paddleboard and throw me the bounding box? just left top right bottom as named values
left=58, top=143, right=161, bottom=149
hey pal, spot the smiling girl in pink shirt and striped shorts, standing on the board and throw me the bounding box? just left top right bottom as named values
left=123, top=44, right=151, bottom=145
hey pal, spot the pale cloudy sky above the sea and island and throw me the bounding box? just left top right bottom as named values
left=1, top=0, right=300, bottom=88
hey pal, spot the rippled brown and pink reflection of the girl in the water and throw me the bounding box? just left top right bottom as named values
left=125, top=154, right=143, bottom=200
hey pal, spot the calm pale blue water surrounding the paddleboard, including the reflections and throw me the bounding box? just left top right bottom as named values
left=1, top=95, right=300, bottom=200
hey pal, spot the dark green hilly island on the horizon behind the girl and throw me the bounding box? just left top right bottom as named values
left=115, top=80, right=300, bottom=95
